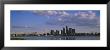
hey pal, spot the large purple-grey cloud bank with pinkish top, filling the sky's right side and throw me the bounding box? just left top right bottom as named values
left=46, top=11, right=100, bottom=27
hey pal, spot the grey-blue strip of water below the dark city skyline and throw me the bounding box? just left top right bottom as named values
left=11, top=36, right=100, bottom=40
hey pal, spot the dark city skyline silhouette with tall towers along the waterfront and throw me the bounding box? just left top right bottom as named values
left=11, top=26, right=100, bottom=39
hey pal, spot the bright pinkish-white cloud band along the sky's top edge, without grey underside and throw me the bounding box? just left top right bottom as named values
left=33, top=10, right=96, bottom=20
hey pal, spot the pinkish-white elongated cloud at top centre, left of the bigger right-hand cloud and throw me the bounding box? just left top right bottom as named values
left=32, top=10, right=69, bottom=17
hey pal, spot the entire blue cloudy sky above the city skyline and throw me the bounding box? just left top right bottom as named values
left=10, top=10, right=100, bottom=33
